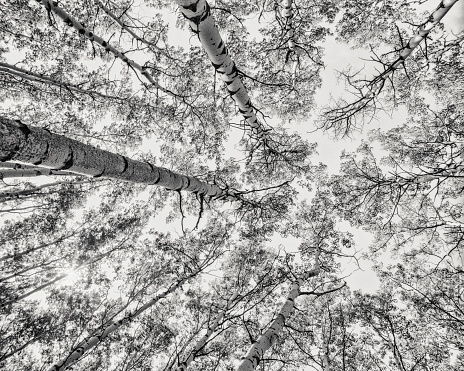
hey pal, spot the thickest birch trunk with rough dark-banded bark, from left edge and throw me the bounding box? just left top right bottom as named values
left=0, top=117, right=242, bottom=201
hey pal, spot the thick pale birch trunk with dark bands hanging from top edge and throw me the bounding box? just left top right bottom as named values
left=176, top=0, right=266, bottom=140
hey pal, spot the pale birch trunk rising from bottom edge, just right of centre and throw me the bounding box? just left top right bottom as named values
left=237, top=249, right=320, bottom=371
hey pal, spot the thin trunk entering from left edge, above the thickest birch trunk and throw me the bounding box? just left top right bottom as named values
left=0, top=62, right=124, bottom=100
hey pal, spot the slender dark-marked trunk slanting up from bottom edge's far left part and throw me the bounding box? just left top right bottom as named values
left=49, top=270, right=199, bottom=371
